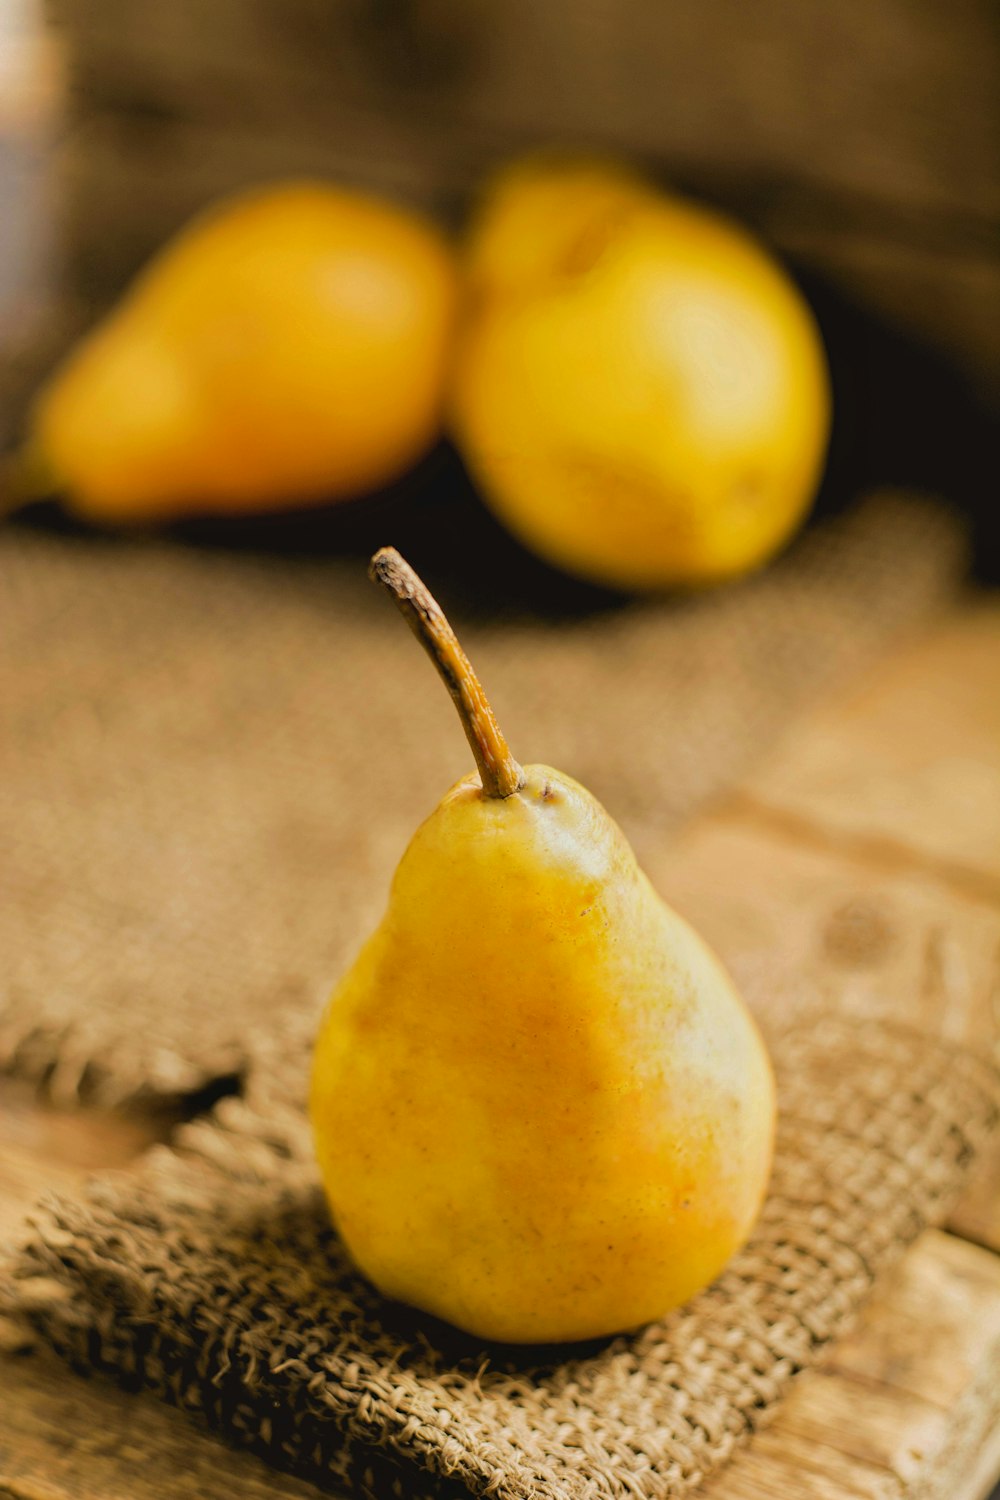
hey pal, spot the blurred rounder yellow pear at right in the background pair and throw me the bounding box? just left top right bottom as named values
left=450, top=156, right=831, bottom=590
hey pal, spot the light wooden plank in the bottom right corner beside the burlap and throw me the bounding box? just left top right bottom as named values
left=699, top=1230, right=1000, bottom=1500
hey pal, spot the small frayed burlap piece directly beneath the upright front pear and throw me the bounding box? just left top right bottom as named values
left=7, top=1019, right=1000, bottom=1500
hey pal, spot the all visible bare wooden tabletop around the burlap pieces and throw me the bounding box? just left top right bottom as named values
left=0, top=596, right=1000, bottom=1500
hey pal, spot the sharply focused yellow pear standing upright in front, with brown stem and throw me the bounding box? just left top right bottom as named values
left=310, top=549, right=775, bottom=1343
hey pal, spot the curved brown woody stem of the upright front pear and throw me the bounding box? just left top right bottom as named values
left=369, top=548, right=525, bottom=798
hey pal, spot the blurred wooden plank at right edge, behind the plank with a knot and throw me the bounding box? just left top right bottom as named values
left=744, top=597, right=1000, bottom=899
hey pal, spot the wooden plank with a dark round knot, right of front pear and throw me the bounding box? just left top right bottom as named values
left=646, top=806, right=1000, bottom=1250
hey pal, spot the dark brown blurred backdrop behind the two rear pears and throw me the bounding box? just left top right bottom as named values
left=0, top=0, right=1000, bottom=597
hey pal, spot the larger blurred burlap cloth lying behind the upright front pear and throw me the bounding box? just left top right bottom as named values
left=0, top=495, right=963, bottom=1104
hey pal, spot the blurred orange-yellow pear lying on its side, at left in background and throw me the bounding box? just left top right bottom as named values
left=24, top=182, right=456, bottom=525
